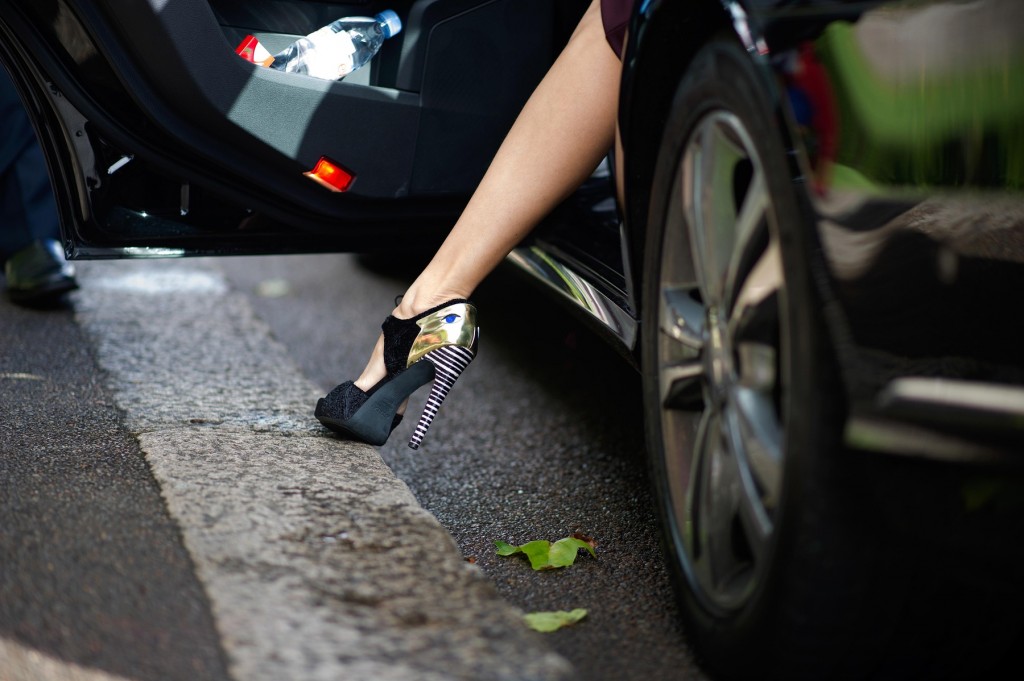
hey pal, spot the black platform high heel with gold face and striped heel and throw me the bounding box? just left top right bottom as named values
left=315, top=299, right=480, bottom=450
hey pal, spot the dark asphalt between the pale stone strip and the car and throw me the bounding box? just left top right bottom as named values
left=218, top=255, right=703, bottom=680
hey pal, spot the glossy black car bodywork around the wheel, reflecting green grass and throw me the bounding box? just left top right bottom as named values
left=617, top=0, right=1024, bottom=462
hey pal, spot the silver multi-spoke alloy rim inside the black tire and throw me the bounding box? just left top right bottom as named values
left=657, top=111, right=785, bottom=612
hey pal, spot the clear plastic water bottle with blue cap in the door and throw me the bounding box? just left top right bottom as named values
left=270, top=9, right=401, bottom=80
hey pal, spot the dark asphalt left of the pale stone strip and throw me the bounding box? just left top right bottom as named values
left=0, top=288, right=228, bottom=681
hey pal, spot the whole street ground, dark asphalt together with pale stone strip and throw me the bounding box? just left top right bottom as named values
left=0, top=256, right=706, bottom=681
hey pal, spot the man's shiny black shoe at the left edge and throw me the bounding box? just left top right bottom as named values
left=4, top=239, right=78, bottom=306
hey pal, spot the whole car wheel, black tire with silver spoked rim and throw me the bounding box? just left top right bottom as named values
left=642, top=41, right=852, bottom=678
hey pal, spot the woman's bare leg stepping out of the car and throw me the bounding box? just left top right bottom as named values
left=355, top=0, right=622, bottom=390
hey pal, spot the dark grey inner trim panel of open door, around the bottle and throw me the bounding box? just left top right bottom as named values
left=211, top=0, right=555, bottom=198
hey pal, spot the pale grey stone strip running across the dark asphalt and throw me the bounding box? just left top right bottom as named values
left=69, top=260, right=570, bottom=681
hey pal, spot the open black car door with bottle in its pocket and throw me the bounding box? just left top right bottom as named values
left=0, top=0, right=584, bottom=257
